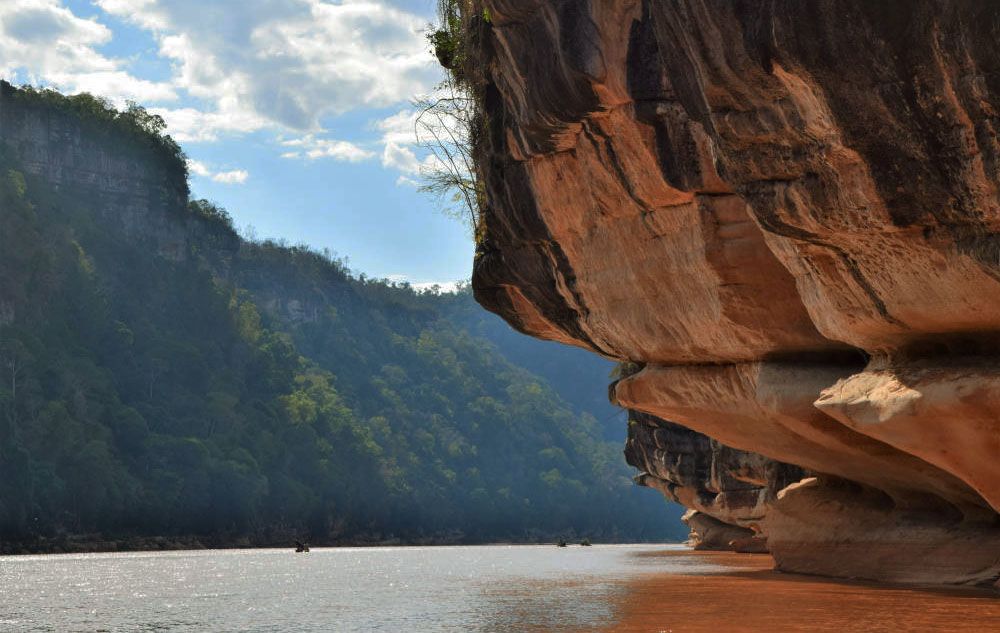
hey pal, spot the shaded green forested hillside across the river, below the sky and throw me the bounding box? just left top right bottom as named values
left=0, top=87, right=681, bottom=550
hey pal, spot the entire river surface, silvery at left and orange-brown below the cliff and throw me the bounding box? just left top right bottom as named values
left=0, top=545, right=1000, bottom=633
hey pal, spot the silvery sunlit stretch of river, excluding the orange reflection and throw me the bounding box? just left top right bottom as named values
left=0, top=545, right=704, bottom=633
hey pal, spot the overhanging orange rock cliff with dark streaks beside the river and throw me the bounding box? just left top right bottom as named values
left=473, top=0, right=1000, bottom=584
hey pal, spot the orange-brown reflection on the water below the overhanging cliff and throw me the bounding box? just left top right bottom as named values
left=603, top=551, right=1000, bottom=633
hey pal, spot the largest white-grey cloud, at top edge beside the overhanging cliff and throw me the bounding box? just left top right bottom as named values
left=96, top=0, right=439, bottom=132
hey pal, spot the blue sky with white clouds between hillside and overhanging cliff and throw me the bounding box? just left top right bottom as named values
left=0, top=0, right=473, bottom=285
